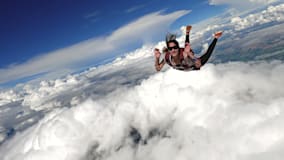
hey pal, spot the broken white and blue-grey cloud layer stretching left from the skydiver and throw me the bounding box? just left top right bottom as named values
left=0, top=46, right=156, bottom=145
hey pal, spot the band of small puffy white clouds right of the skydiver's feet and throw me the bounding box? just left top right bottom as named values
left=191, top=3, right=284, bottom=46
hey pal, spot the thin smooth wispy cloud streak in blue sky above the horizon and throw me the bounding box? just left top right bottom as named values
left=0, top=10, right=189, bottom=83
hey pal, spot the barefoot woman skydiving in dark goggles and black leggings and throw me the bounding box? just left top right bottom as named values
left=154, top=26, right=222, bottom=71
